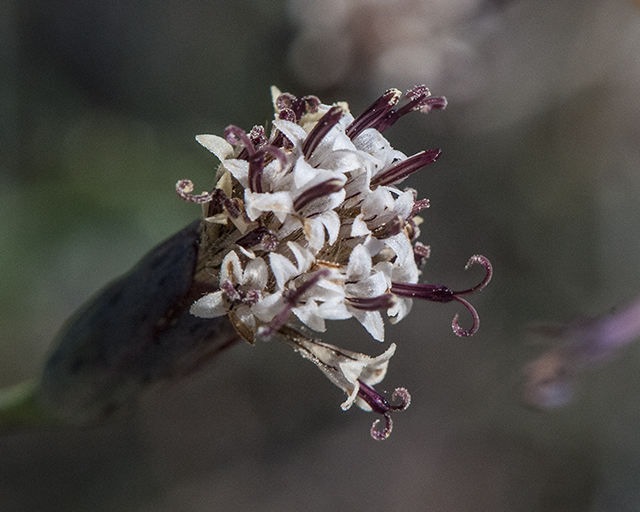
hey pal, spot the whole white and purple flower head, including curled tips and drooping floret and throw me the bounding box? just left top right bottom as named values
left=176, top=86, right=492, bottom=439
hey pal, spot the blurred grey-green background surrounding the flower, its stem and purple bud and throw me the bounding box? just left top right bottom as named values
left=0, top=0, right=640, bottom=512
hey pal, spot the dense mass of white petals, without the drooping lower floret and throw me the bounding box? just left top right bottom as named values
left=185, top=90, right=436, bottom=341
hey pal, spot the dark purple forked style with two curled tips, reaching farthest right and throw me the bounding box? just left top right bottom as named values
left=391, top=255, right=493, bottom=337
